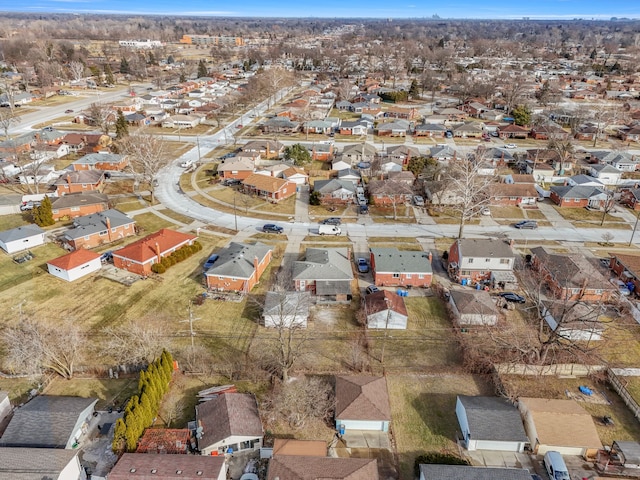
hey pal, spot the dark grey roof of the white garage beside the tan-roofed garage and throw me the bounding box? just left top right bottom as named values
left=458, top=395, right=528, bottom=442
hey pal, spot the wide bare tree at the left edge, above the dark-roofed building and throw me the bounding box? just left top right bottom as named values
left=3, top=319, right=86, bottom=379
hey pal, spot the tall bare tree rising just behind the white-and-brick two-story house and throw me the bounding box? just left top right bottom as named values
left=443, top=155, right=494, bottom=238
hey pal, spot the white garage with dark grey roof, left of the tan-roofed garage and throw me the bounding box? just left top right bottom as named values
left=456, top=395, right=529, bottom=453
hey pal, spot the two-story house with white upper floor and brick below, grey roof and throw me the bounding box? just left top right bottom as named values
left=447, top=238, right=515, bottom=285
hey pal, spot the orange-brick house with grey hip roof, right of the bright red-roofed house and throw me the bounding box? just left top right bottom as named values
left=204, top=242, right=273, bottom=293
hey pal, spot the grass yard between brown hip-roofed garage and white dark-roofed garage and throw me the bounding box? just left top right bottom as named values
left=387, top=374, right=493, bottom=478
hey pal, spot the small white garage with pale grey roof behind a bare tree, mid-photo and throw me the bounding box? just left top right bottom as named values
left=262, top=292, right=311, bottom=328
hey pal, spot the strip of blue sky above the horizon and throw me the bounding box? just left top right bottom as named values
left=0, top=0, right=640, bottom=20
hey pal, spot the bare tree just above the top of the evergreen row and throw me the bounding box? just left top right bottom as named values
left=100, top=316, right=168, bottom=365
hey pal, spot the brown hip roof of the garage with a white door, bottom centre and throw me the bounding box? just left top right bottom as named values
left=336, top=375, right=391, bottom=421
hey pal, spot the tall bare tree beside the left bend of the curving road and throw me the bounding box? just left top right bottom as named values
left=120, top=130, right=169, bottom=203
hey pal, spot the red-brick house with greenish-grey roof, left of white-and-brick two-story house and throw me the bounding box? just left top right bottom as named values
left=369, top=248, right=433, bottom=287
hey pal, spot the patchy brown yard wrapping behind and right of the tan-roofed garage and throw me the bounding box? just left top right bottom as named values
left=500, top=375, right=640, bottom=445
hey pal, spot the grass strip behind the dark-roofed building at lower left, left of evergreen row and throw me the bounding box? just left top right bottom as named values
left=43, top=375, right=138, bottom=410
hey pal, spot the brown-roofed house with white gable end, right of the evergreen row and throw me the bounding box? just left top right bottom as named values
left=196, top=393, right=264, bottom=458
